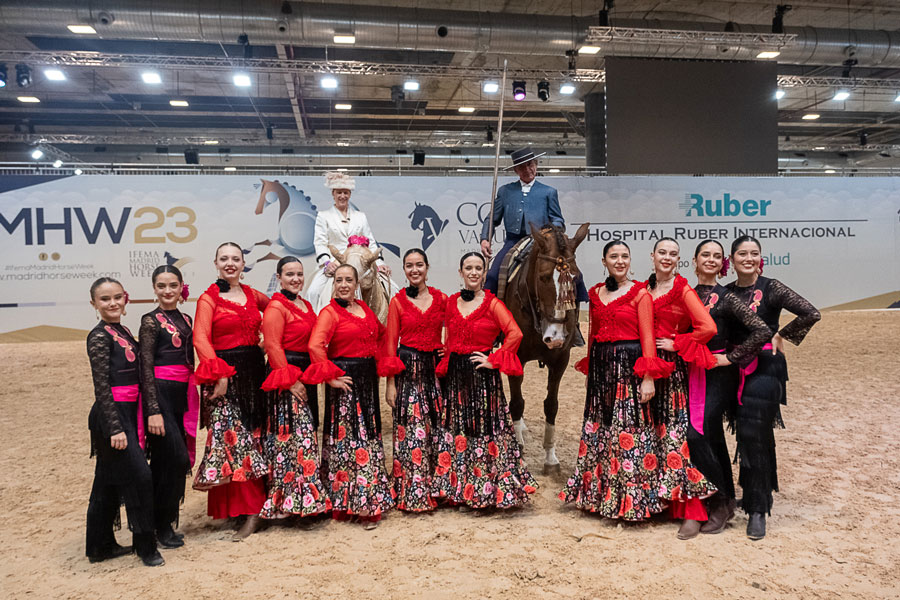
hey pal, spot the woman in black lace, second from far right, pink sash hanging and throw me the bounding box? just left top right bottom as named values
left=687, top=240, right=772, bottom=533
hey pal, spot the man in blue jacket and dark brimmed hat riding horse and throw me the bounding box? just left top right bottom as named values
left=481, top=148, right=588, bottom=302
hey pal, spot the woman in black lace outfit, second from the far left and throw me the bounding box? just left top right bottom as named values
left=140, top=265, right=198, bottom=548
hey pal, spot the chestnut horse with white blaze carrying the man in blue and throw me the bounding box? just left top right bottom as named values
left=504, top=223, right=590, bottom=475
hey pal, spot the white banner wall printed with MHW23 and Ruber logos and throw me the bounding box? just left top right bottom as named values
left=0, top=175, right=900, bottom=332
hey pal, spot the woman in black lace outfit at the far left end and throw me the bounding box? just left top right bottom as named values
left=86, top=277, right=165, bottom=566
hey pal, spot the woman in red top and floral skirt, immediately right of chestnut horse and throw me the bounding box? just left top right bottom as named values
left=559, top=240, right=672, bottom=521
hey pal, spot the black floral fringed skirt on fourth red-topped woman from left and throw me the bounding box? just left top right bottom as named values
left=393, top=346, right=441, bottom=512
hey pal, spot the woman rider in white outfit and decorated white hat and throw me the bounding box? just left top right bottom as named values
left=307, top=172, right=393, bottom=313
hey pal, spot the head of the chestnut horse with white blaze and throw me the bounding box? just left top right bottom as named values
left=528, top=223, right=590, bottom=349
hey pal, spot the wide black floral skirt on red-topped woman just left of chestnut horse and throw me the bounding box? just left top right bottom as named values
left=434, top=354, right=537, bottom=508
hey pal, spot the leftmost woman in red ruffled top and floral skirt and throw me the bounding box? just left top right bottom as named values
left=194, top=242, right=269, bottom=540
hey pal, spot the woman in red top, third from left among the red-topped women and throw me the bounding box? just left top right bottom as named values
left=303, top=265, right=394, bottom=529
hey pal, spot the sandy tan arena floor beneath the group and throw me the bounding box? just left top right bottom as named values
left=0, top=311, right=900, bottom=600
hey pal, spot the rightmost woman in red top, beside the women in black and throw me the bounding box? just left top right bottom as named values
left=647, top=238, right=716, bottom=539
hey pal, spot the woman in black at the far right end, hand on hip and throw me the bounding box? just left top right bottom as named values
left=727, top=236, right=821, bottom=539
